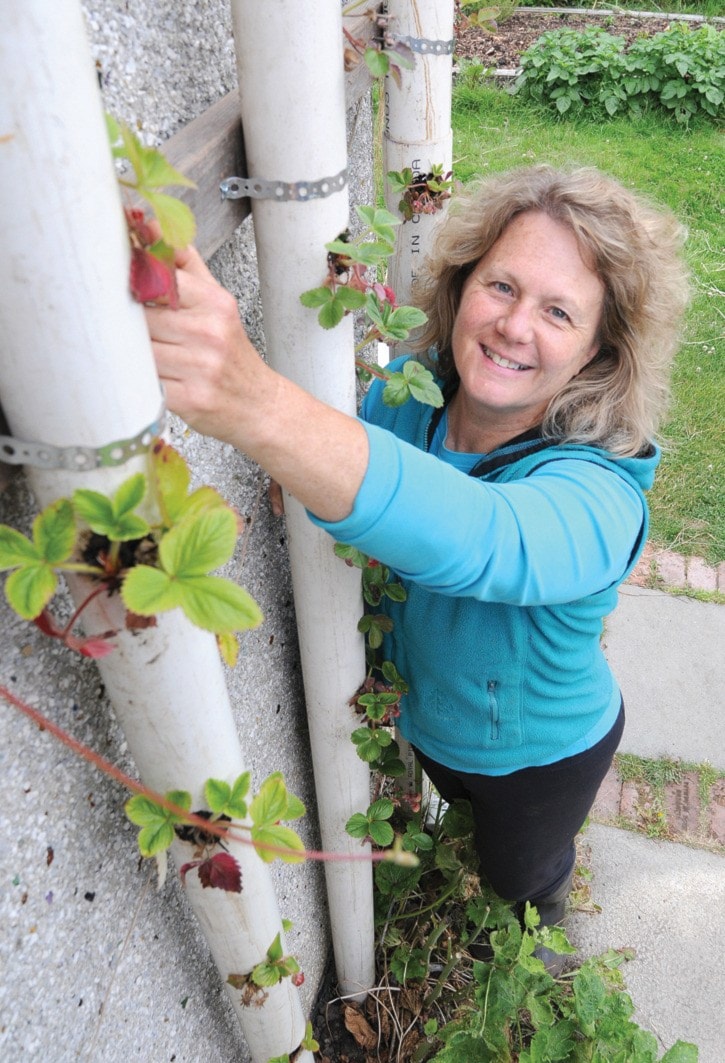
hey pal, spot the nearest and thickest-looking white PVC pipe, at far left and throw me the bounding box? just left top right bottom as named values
left=0, top=0, right=311, bottom=1063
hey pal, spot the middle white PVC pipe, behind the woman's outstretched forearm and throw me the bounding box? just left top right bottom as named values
left=232, top=0, right=374, bottom=994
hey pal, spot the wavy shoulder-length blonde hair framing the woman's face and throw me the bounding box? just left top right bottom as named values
left=414, top=166, right=690, bottom=456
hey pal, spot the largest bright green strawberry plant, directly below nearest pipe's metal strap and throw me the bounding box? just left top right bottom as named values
left=0, top=440, right=262, bottom=664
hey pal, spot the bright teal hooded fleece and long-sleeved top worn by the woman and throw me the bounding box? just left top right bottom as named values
left=310, top=359, right=659, bottom=775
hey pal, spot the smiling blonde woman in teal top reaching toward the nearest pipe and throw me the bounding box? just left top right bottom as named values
left=148, top=167, right=687, bottom=973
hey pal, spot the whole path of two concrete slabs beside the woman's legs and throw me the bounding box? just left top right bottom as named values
left=569, top=585, right=725, bottom=1063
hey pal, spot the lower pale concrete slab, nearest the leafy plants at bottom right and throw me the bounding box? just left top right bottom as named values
left=568, top=824, right=725, bottom=1063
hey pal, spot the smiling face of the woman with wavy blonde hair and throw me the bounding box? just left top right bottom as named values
left=452, top=210, right=604, bottom=435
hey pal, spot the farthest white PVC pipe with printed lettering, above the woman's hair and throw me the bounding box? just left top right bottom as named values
left=383, top=0, right=453, bottom=304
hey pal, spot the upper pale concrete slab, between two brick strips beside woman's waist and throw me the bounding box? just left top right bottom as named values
left=603, top=585, right=725, bottom=770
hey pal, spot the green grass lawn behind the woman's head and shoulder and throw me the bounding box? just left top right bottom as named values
left=453, top=83, right=725, bottom=563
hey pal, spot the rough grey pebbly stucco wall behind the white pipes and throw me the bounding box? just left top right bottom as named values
left=0, top=0, right=371, bottom=1063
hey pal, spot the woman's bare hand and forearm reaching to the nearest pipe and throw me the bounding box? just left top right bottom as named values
left=146, top=248, right=368, bottom=521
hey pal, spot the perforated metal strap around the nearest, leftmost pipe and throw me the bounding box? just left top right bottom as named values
left=0, top=404, right=166, bottom=472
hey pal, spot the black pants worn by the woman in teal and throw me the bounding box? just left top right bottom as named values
left=416, top=704, right=624, bottom=902
